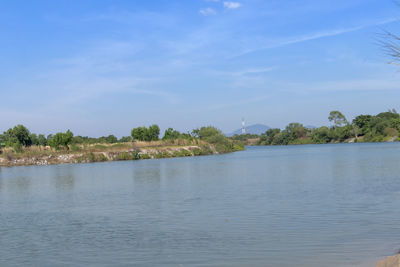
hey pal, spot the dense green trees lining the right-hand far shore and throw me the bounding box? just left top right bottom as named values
left=232, top=109, right=400, bottom=145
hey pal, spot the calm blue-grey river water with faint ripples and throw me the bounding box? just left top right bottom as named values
left=0, top=144, right=400, bottom=267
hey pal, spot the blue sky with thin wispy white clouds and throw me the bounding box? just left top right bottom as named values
left=0, top=0, right=400, bottom=137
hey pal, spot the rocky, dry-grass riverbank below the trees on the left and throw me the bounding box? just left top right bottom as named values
left=0, top=140, right=244, bottom=167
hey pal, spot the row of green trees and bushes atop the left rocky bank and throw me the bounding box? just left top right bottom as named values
left=0, top=124, right=243, bottom=153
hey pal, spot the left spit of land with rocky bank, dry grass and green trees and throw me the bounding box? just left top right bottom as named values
left=0, top=125, right=244, bottom=166
